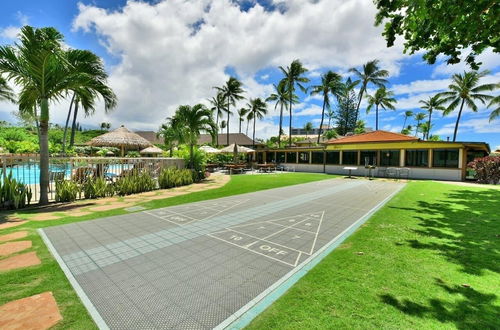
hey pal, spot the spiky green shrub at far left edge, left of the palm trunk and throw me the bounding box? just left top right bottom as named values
left=0, top=171, right=33, bottom=209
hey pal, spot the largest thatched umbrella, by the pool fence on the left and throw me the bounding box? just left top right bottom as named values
left=87, top=125, right=152, bottom=157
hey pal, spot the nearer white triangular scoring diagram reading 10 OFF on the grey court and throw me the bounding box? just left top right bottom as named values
left=208, top=211, right=324, bottom=267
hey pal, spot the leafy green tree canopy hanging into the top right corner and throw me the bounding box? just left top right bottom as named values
left=374, top=0, right=500, bottom=70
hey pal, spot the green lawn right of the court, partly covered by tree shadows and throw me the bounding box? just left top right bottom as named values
left=248, top=182, right=500, bottom=329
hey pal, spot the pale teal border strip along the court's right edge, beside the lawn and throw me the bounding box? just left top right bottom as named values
left=214, top=183, right=407, bottom=330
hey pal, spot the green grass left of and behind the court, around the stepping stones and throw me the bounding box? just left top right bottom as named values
left=0, top=173, right=334, bottom=329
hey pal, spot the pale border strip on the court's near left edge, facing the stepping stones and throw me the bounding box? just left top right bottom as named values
left=37, top=228, right=109, bottom=330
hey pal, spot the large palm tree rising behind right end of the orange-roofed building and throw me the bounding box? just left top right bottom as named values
left=438, top=71, right=498, bottom=142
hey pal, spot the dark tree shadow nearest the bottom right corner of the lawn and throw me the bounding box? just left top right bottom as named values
left=380, top=278, right=500, bottom=329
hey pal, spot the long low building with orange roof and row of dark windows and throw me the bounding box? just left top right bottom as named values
left=257, top=130, right=490, bottom=181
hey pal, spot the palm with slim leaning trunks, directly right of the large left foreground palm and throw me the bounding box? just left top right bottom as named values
left=62, top=49, right=117, bottom=153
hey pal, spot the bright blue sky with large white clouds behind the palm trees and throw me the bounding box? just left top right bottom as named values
left=0, top=0, right=500, bottom=148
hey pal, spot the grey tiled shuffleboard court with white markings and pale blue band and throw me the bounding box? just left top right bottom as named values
left=40, top=179, right=404, bottom=329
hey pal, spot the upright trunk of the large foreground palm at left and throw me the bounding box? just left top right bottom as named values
left=38, top=99, right=49, bottom=205
